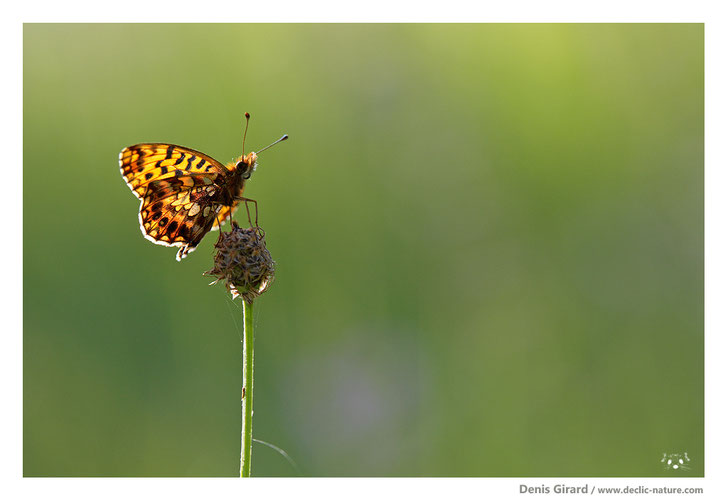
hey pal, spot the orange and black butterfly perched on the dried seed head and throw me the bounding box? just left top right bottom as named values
left=119, top=113, right=288, bottom=261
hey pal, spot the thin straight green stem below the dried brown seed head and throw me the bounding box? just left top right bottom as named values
left=240, top=299, right=253, bottom=477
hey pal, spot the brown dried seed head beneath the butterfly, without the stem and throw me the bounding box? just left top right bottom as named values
left=203, top=221, right=275, bottom=302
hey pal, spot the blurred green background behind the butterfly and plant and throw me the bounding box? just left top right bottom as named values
left=23, top=24, right=704, bottom=476
